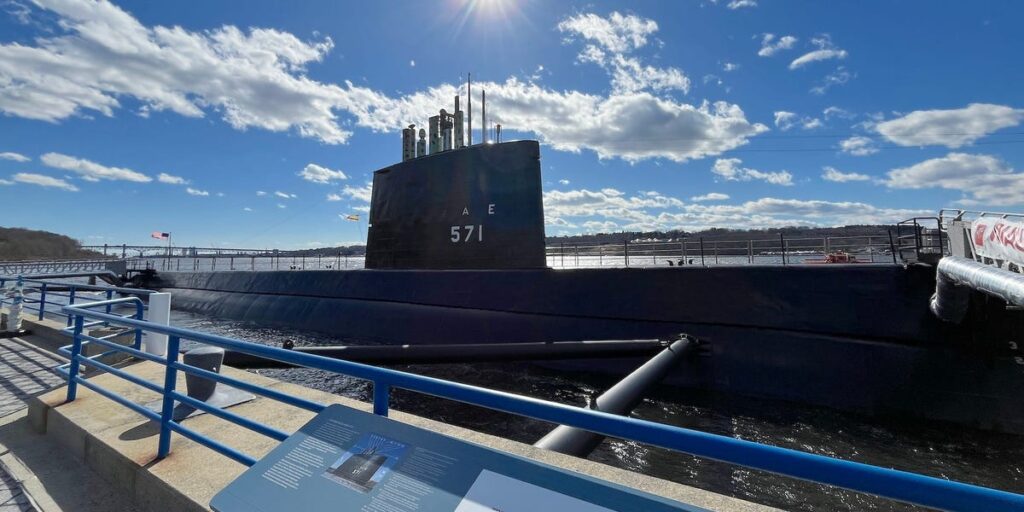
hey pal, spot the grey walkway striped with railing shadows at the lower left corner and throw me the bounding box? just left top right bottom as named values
left=0, top=338, right=135, bottom=512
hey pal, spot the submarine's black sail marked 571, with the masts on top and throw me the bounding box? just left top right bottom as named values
left=366, top=85, right=547, bottom=269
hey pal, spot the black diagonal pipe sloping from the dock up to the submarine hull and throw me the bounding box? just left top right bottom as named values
left=534, top=335, right=698, bottom=457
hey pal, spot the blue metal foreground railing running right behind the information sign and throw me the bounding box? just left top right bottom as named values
left=63, top=302, right=1024, bottom=511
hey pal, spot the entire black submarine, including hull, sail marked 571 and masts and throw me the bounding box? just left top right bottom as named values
left=135, top=91, right=1024, bottom=433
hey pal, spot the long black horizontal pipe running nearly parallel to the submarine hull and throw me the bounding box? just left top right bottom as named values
left=224, top=340, right=668, bottom=369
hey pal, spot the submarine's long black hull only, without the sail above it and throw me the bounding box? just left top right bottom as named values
left=151, top=264, right=1024, bottom=432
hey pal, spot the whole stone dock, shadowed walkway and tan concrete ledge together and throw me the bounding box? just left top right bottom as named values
left=0, top=313, right=772, bottom=512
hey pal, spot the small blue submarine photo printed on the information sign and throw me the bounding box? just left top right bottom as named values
left=324, top=432, right=409, bottom=493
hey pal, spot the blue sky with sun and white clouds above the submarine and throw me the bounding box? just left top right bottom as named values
left=0, top=0, right=1024, bottom=248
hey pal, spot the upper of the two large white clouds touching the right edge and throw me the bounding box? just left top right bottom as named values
left=876, top=103, right=1024, bottom=147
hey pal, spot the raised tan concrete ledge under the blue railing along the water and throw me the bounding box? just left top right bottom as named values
left=29, top=362, right=771, bottom=511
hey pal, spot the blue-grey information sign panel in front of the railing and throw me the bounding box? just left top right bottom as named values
left=210, top=404, right=705, bottom=512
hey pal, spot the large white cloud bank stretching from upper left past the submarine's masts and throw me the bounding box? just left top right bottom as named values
left=0, top=0, right=767, bottom=162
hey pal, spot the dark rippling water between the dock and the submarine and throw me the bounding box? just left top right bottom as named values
left=172, top=311, right=1024, bottom=511
